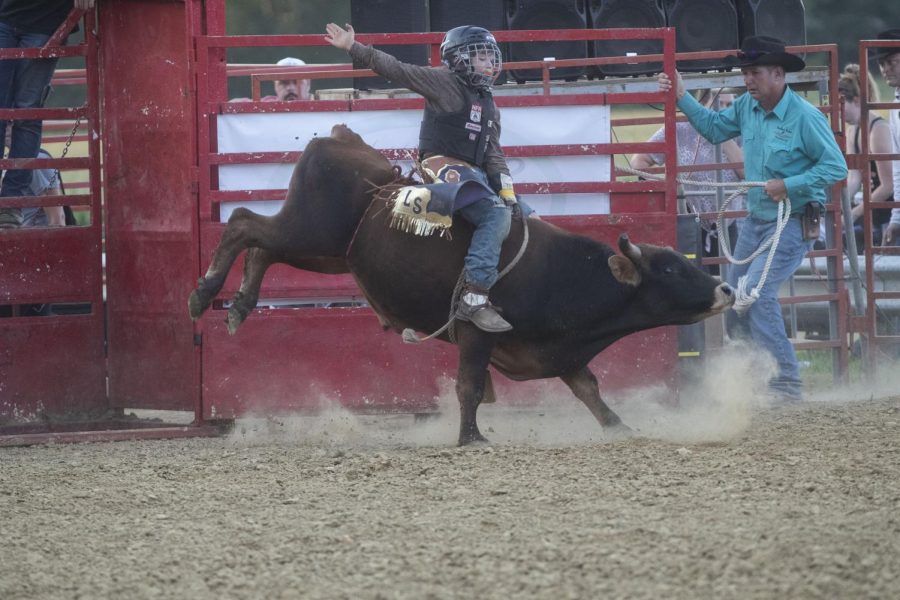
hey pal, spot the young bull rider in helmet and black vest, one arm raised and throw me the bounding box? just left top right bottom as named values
left=325, top=23, right=531, bottom=333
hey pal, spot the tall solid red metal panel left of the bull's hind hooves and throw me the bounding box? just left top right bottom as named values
left=98, top=0, right=199, bottom=410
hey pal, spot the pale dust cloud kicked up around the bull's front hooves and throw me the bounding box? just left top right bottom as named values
left=230, top=344, right=800, bottom=448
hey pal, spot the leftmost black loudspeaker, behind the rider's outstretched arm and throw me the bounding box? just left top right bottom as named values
left=350, top=0, right=428, bottom=90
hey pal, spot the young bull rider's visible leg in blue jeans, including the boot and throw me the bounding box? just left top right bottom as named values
left=457, top=196, right=512, bottom=332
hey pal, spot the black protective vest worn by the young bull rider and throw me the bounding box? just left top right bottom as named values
left=419, top=85, right=497, bottom=168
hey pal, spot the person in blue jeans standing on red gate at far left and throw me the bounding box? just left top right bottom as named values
left=0, top=0, right=95, bottom=229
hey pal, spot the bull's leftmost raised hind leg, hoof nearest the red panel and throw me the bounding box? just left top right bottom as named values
left=188, top=208, right=273, bottom=320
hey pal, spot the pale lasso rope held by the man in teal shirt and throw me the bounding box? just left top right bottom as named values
left=616, top=167, right=791, bottom=315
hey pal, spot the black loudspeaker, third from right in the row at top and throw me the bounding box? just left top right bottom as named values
left=589, top=0, right=666, bottom=77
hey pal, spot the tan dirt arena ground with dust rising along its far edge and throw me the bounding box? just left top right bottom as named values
left=0, top=354, right=900, bottom=600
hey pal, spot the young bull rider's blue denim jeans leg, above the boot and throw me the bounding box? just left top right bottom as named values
left=457, top=196, right=512, bottom=290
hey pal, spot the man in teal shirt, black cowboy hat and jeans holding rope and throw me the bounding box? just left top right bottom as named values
left=659, top=36, right=847, bottom=400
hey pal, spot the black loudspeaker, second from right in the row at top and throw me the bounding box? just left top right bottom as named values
left=666, top=0, right=740, bottom=71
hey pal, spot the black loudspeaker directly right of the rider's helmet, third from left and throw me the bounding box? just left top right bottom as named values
left=506, top=0, right=588, bottom=83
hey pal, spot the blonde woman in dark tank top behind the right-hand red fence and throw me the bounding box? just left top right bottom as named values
left=838, top=64, right=894, bottom=247
